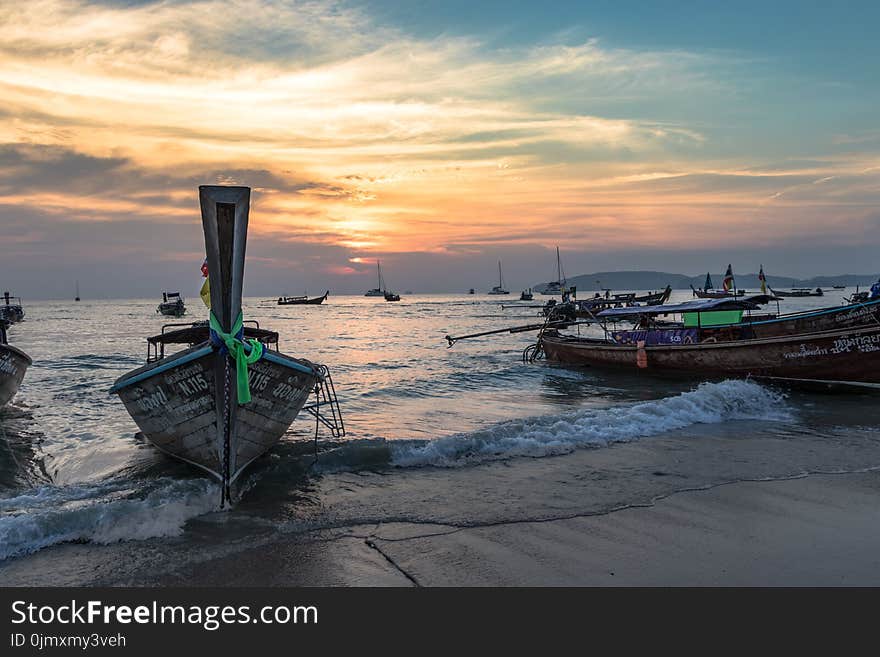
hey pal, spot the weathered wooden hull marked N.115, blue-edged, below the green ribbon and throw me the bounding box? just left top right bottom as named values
left=111, top=342, right=319, bottom=484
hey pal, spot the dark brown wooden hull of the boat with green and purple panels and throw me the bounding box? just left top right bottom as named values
left=541, top=326, right=880, bottom=384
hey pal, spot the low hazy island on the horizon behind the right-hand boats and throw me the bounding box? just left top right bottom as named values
left=532, top=271, right=880, bottom=292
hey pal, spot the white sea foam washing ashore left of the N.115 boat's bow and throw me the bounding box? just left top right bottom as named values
left=0, top=479, right=219, bottom=560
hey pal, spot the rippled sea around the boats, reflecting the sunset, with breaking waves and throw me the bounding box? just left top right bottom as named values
left=0, top=290, right=880, bottom=584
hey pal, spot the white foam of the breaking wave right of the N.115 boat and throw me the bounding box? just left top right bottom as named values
left=391, top=380, right=791, bottom=467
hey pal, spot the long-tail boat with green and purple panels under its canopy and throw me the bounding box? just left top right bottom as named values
left=533, top=296, right=880, bottom=386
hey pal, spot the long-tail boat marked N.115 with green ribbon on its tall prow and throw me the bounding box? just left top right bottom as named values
left=111, top=186, right=344, bottom=503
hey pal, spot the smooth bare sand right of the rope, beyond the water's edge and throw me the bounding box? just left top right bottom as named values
left=362, top=473, right=880, bottom=586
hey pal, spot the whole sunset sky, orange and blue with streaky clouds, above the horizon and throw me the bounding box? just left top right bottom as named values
left=0, top=0, right=880, bottom=298
